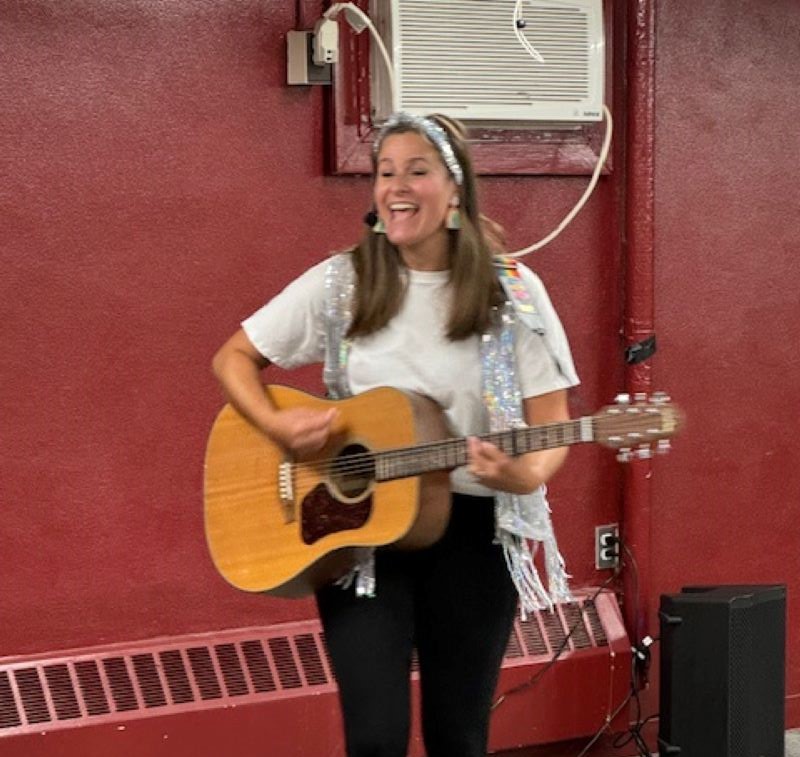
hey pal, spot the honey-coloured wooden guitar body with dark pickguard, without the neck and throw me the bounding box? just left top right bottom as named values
left=204, top=386, right=450, bottom=597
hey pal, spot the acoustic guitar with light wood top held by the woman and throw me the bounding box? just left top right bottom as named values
left=204, top=385, right=681, bottom=597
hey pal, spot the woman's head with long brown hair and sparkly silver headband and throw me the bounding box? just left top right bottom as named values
left=350, top=113, right=503, bottom=339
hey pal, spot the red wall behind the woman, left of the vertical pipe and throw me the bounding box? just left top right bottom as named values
left=0, top=0, right=620, bottom=654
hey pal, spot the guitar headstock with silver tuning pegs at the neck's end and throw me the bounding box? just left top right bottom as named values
left=592, top=392, right=683, bottom=462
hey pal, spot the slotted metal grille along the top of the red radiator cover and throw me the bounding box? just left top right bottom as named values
left=0, top=595, right=608, bottom=738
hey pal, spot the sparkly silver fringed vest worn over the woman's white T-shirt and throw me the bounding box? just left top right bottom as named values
left=323, top=253, right=572, bottom=619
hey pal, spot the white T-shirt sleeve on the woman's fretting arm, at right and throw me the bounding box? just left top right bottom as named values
left=514, top=264, right=580, bottom=397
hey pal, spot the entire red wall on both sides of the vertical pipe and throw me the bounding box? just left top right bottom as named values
left=0, top=0, right=800, bottom=744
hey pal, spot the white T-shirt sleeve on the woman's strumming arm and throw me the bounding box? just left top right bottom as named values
left=242, top=260, right=328, bottom=369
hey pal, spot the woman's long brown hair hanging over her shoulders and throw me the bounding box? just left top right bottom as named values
left=347, top=114, right=503, bottom=341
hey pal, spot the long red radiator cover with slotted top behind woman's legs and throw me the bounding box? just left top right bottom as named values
left=0, top=589, right=630, bottom=757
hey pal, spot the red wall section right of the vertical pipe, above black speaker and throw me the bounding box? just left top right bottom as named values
left=651, top=0, right=800, bottom=726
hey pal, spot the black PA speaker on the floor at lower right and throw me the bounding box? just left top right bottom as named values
left=658, top=585, right=786, bottom=757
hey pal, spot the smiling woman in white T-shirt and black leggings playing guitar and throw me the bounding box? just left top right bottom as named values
left=209, top=114, right=577, bottom=757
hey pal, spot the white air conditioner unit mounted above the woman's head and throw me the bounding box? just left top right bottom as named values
left=371, top=0, right=605, bottom=122
